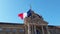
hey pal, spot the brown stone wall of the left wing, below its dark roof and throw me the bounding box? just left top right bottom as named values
left=0, top=24, right=25, bottom=34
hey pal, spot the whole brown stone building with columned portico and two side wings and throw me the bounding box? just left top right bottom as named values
left=0, top=9, right=60, bottom=34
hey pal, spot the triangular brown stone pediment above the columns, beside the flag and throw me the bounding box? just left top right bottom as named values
left=24, top=9, right=48, bottom=24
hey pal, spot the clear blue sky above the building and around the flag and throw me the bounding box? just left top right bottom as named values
left=0, top=0, right=60, bottom=25
